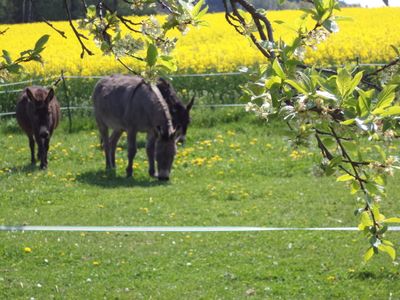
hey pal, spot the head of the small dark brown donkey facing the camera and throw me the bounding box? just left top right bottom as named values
left=25, top=88, right=54, bottom=139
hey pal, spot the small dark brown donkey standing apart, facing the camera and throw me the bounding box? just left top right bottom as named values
left=16, top=86, right=61, bottom=169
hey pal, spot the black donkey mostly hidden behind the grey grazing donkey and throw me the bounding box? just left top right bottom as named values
left=157, top=78, right=194, bottom=144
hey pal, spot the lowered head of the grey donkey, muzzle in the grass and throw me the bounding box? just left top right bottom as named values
left=154, top=127, right=177, bottom=180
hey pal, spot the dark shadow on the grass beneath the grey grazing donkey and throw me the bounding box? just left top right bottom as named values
left=76, top=170, right=169, bottom=188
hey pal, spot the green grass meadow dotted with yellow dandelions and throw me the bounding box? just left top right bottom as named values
left=0, top=109, right=400, bottom=299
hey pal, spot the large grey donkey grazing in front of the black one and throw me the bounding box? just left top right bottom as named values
left=92, top=75, right=176, bottom=180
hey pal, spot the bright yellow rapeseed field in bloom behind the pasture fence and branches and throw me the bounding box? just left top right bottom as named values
left=0, top=8, right=400, bottom=75
